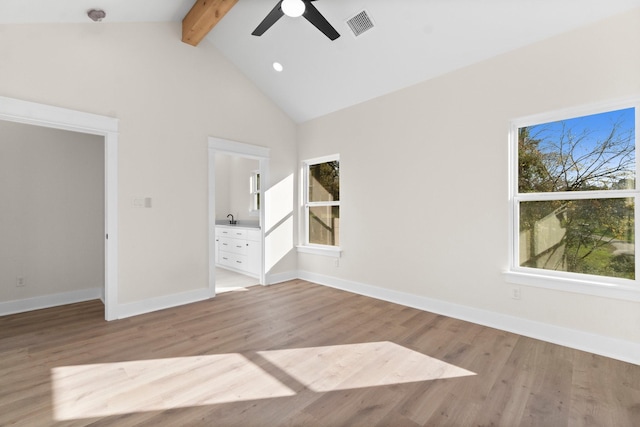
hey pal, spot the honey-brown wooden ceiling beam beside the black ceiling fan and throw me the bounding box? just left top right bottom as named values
left=182, top=0, right=238, bottom=46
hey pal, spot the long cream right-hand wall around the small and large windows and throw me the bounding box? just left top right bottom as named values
left=298, top=10, right=640, bottom=343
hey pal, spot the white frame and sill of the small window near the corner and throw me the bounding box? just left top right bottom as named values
left=298, top=154, right=342, bottom=257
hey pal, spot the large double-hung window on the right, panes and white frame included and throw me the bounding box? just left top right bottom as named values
left=511, top=103, right=638, bottom=296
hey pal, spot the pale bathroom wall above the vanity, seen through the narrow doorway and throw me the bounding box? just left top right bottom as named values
left=215, top=153, right=260, bottom=223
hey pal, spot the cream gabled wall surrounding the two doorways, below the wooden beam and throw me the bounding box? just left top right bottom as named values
left=0, top=23, right=296, bottom=304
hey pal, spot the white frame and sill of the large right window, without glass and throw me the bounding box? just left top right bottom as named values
left=504, top=97, right=640, bottom=301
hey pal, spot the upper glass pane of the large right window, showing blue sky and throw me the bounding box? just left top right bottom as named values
left=518, top=108, right=636, bottom=193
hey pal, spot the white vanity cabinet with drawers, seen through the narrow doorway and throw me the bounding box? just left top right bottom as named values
left=216, top=225, right=262, bottom=277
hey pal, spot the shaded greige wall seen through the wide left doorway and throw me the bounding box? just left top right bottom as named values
left=0, top=120, right=104, bottom=302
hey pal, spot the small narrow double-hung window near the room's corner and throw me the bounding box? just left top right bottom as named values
left=304, top=155, right=340, bottom=247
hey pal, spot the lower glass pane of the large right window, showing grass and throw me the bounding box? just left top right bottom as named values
left=519, top=198, right=635, bottom=279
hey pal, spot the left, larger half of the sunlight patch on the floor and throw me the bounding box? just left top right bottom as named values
left=51, top=354, right=295, bottom=421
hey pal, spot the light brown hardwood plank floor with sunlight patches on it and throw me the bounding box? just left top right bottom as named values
left=0, top=281, right=640, bottom=427
